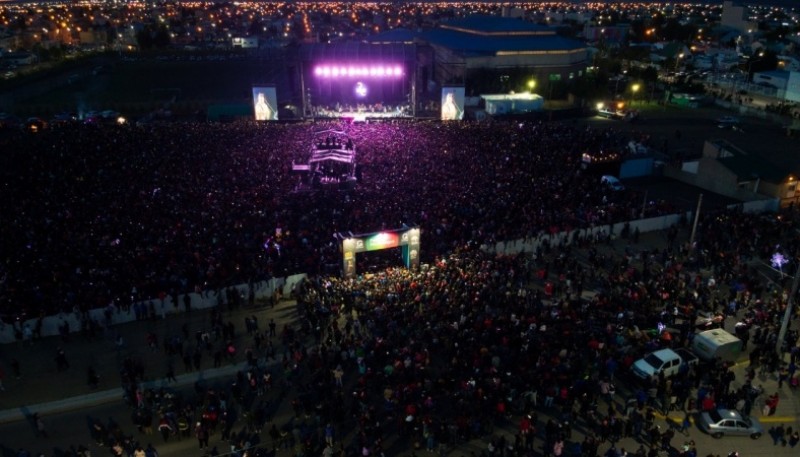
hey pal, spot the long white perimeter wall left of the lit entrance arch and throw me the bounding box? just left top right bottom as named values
left=0, top=274, right=306, bottom=343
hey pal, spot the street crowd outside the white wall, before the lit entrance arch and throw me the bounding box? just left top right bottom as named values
left=3, top=211, right=800, bottom=457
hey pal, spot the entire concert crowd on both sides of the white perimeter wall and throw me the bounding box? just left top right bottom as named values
left=0, top=118, right=800, bottom=457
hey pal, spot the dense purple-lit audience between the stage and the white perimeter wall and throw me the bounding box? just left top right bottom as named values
left=0, top=122, right=656, bottom=318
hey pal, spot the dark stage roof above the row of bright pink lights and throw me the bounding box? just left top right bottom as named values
left=300, top=41, right=417, bottom=63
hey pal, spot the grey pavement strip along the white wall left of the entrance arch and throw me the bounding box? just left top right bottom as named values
left=0, top=300, right=296, bottom=423
